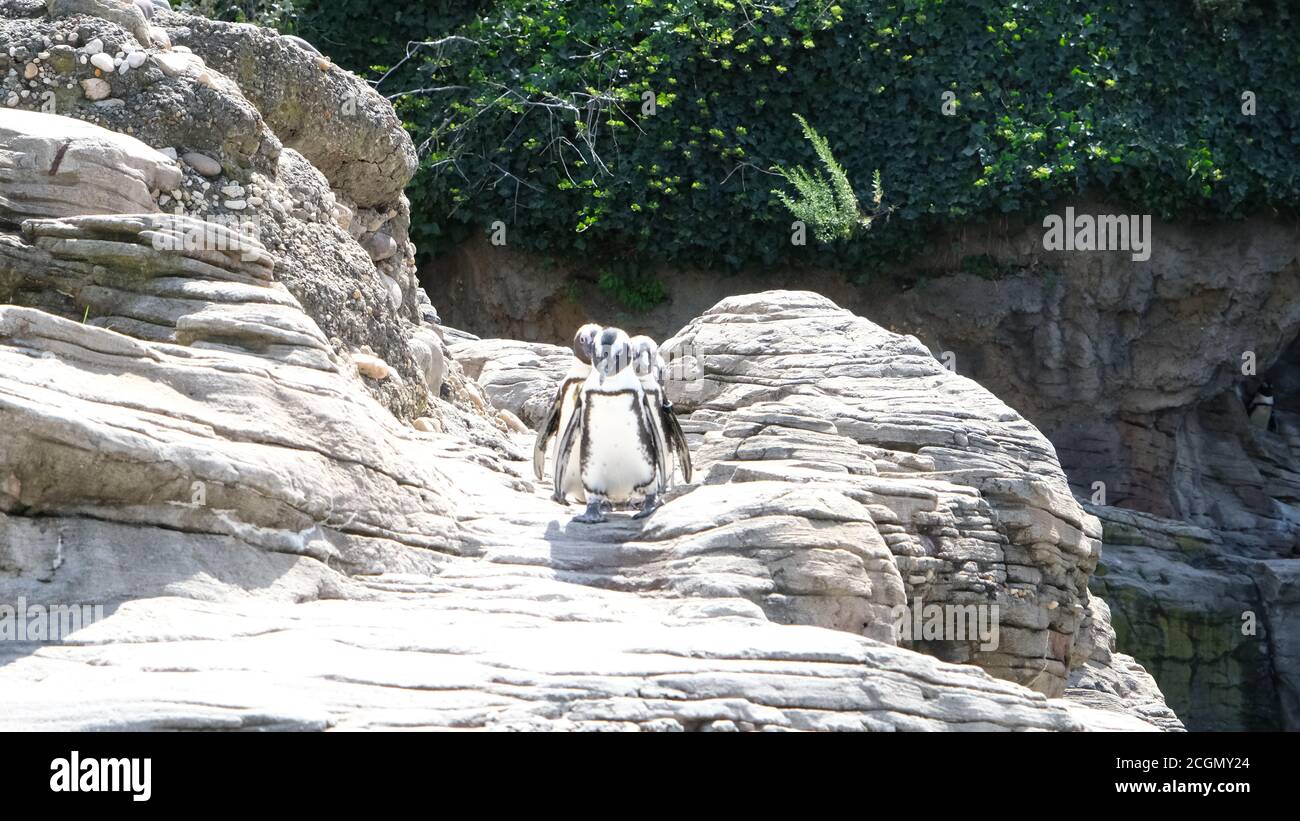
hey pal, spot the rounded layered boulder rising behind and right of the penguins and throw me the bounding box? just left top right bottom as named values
left=451, top=292, right=1178, bottom=726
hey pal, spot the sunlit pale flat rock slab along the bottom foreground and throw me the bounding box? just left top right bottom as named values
left=0, top=589, right=1083, bottom=731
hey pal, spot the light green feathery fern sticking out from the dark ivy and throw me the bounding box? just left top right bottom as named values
left=772, top=114, right=884, bottom=243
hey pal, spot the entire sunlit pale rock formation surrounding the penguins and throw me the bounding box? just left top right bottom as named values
left=0, top=0, right=1179, bottom=730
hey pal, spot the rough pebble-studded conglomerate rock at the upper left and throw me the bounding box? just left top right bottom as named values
left=0, top=0, right=441, bottom=418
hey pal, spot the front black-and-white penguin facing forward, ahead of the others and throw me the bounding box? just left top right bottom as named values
left=555, top=327, right=664, bottom=524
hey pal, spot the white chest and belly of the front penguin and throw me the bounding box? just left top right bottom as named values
left=582, top=391, right=655, bottom=501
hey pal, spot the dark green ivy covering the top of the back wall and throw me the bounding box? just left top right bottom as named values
left=287, top=0, right=1300, bottom=293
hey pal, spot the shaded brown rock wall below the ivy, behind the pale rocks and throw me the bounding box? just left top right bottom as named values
left=424, top=203, right=1300, bottom=729
